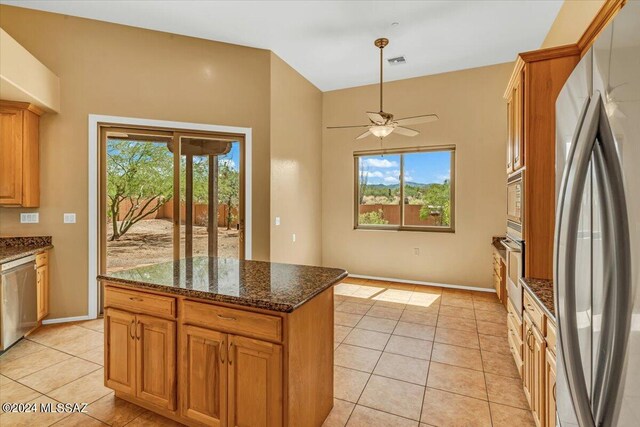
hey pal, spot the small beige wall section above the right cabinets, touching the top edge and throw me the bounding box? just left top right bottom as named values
left=541, top=0, right=605, bottom=48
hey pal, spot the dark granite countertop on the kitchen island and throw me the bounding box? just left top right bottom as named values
left=98, top=257, right=347, bottom=313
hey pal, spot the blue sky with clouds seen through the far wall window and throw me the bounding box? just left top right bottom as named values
left=360, top=151, right=451, bottom=185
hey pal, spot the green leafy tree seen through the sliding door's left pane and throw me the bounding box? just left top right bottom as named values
left=107, top=139, right=173, bottom=241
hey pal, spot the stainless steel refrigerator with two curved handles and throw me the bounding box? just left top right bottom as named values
left=554, top=1, right=640, bottom=427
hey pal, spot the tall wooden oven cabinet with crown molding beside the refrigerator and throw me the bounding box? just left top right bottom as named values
left=504, top=45, right=580, bottom=279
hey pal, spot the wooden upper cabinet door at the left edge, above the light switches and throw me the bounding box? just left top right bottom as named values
left=0, top=107, right=24, bottom=205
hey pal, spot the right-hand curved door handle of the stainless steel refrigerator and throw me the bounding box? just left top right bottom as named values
left=593, top=92, right=633, bottom=427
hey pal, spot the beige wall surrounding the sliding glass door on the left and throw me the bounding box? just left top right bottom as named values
left=0, top=6, right=271, bottom=318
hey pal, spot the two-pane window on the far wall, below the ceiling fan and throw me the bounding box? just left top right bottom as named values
left=354, top=147, right=455, bottom=232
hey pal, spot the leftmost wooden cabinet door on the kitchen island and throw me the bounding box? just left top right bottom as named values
left=104, top=308, right=136, bottom=395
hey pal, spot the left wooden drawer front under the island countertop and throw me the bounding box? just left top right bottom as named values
left=104, top=286, right=176, bottom=318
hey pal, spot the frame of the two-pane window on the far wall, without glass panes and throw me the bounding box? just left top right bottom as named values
left=353, top=145, right=456, bottom=233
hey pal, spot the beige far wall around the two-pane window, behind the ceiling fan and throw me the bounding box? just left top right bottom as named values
left=322, top=63, right=513, bottom=288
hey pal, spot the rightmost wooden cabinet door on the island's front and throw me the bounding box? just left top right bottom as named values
left=228, top=335, right=283, bottom=427
